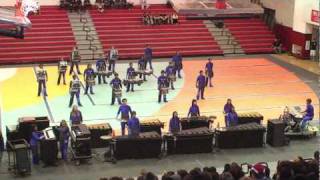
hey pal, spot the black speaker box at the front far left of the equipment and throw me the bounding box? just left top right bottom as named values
left=15, top=148, right=31, bottom=173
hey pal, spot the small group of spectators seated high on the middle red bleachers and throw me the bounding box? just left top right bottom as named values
left=142, top=13, right=179, bottom=25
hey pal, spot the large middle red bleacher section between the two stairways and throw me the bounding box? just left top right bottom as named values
left=90, top=5, right=223, bottom=59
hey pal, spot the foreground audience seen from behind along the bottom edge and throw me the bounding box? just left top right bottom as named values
left=100, top=151, right=319, bottom=180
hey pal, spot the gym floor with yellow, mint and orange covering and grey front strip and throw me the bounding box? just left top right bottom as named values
left=0, top=55, right=320, bottom=179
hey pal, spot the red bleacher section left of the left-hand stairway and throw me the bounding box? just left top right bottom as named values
left=0, top=6, right=76, bottom=64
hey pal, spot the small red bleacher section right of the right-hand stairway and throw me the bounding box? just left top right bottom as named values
left=224, top=18, right=275, bottom=54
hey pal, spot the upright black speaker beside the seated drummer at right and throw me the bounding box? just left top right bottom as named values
left=267, top=119, right=286, bottom=147
